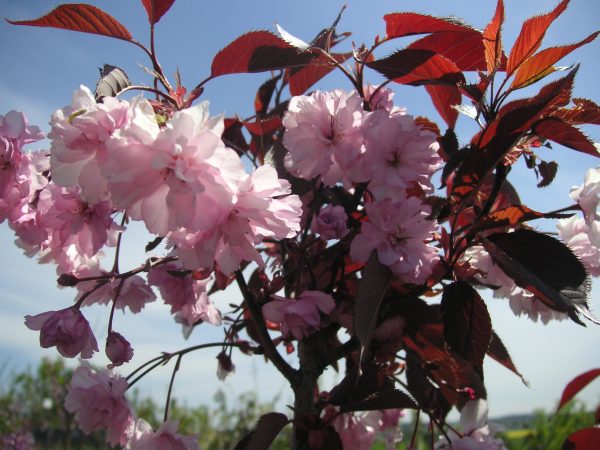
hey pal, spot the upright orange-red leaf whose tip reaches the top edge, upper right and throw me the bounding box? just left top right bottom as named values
left=506, top=0, right=569, bottom=76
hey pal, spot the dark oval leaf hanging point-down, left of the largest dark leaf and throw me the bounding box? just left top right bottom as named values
left=441, top=281, right=492, bottom=372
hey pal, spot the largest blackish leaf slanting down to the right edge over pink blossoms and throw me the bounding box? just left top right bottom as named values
left=483, top=230, right=597, bottom=325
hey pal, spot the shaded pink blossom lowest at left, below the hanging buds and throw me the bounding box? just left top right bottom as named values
left=65, top=365, right=133, bottom=446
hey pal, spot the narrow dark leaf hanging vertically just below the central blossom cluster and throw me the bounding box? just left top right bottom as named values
left=354, top=252, right=392, bottom=360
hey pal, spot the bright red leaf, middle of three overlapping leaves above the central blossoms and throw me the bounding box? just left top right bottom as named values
left=407, top=30, right=486, bottom=70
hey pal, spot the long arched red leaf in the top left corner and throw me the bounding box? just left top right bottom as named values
left=7, top=3, right=132, bottom=41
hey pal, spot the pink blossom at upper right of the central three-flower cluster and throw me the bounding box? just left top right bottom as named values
left=364, top=111, right=442, bottom=199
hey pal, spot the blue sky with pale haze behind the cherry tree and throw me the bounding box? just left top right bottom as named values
left=0, top=0, right=600, bottom=422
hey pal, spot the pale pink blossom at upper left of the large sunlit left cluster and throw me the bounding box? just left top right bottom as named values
left=48, top=85, right=130, bottom=204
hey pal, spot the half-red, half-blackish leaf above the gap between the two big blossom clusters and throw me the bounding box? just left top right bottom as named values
left=211, top=31, right=314, bottom=77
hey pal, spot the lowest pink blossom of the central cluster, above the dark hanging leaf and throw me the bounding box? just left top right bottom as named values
left=350, top=197, right=438, bottom=284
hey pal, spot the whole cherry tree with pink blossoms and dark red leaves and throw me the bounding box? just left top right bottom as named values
left=0, top=0, right=600, bottom=450
